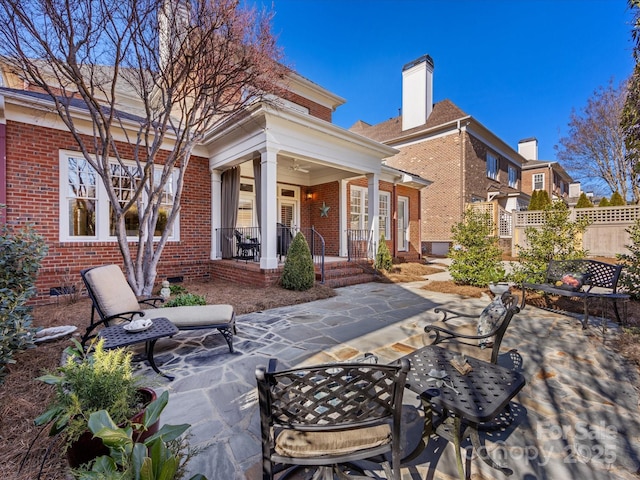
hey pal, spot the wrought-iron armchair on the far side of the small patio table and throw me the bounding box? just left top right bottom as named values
left=424, top=292, right=520, bottom=363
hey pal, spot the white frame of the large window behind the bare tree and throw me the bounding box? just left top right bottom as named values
left=58, top=150, right=180, bottom=242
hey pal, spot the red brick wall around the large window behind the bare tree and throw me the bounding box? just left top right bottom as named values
left=7, top=121, right=211, bottom=303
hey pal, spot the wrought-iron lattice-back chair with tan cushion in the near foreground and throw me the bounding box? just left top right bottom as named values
left=256, top=360, right=409, bottom=480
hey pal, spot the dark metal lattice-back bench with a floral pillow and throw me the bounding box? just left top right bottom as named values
left=520, top=260, right=629, bottom=329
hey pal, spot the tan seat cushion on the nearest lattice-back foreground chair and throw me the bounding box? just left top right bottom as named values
left=275, top=424, right=391, bottom=458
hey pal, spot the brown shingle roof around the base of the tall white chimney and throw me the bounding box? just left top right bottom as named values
left=349, top=99, right=468, bottom=143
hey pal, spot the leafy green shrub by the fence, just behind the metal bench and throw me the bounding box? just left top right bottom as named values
left=512, top=200, right=589, bottom=283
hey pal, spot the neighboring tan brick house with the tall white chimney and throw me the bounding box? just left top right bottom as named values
left=350, top=55, right=529, bottom=255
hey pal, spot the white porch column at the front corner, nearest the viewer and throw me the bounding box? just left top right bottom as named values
left=260, top=148, right=278, bottom=269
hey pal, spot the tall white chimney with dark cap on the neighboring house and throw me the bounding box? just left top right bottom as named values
left=402, top=55, right=433, bottom=130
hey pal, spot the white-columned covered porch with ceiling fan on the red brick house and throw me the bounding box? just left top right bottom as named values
left=205, top=92, right=429, bottom=284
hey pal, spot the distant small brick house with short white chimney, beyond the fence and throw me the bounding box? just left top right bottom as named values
left=518, top=138, right=573, bottom=201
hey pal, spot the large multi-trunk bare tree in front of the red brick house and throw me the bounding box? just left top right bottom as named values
left=0, top=0, right=283, bottom=294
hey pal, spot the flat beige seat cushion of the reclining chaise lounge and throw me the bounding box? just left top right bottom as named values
left=144, top=305, right=233, bottom=329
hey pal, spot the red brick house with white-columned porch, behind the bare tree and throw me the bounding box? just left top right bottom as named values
left=0, top=67, right=429, bottom=303
